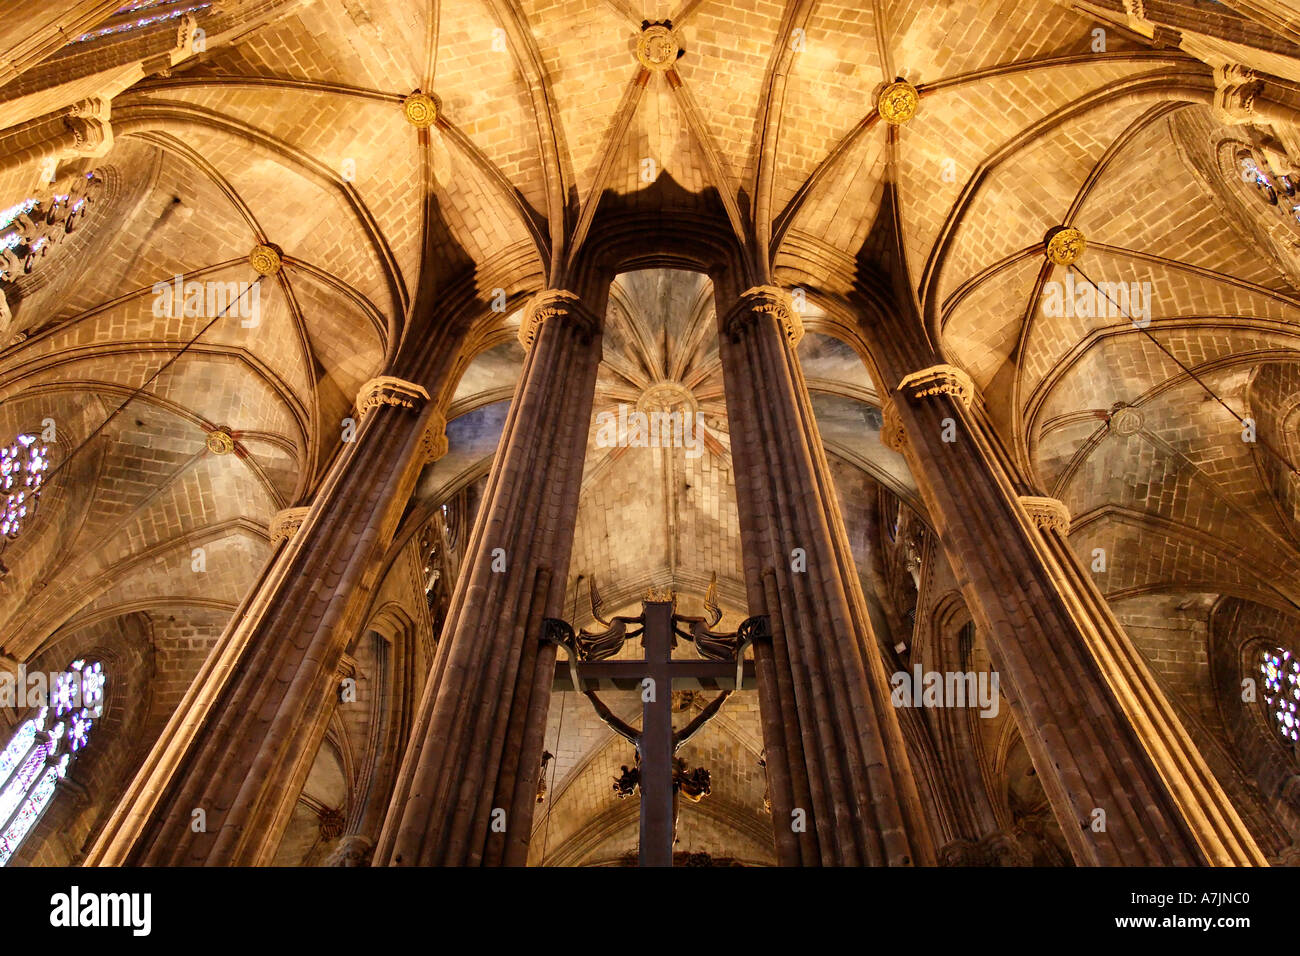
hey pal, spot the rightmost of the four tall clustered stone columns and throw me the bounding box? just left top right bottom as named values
left=875, top=361, right=1264, bottom=865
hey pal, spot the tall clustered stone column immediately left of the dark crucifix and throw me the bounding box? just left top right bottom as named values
left=374, top=291, right=601, bottom=866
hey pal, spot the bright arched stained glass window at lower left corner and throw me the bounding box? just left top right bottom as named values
left=0, top=661, right=107, bottom=866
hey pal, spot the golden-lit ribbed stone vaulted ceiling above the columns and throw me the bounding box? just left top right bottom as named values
left=0, top=0, right=1300, bottom=863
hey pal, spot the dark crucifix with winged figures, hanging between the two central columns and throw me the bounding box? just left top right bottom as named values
left=543, top=585, right=768, bottom=866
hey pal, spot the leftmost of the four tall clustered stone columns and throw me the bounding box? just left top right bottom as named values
left=87, top=377, right=446, bottom=865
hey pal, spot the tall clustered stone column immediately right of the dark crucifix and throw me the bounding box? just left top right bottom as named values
left=719, top=286, right=932, bottom=865
